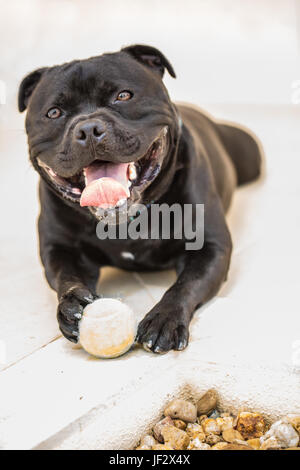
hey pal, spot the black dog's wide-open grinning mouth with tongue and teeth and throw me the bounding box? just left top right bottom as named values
left=37, top=127, right=168, bottom=209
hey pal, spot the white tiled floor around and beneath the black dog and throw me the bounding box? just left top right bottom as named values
left=0, top=106, right=300, bottom=448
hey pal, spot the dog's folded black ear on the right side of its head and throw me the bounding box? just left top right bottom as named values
left=121, top=44, right=176, bottom=78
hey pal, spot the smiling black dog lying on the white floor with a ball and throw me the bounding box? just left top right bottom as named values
left=19, top=45, right=261, bottom=353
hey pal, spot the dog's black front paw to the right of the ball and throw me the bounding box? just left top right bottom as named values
left=136, top=304, right=189, bottom=354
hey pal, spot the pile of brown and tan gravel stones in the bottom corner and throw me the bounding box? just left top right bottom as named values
left=136, top=390, right=300, bottom=450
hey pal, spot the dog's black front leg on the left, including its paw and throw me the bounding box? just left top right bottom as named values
left=38, top=195, right=101, bottom=343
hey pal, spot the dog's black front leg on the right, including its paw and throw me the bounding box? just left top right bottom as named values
left=137, top=197, right=232, bottom=353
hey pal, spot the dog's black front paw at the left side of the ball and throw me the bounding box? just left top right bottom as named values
left=57, top=285, right=97, bottom=343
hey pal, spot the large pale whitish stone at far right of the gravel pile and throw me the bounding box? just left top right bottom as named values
left=260, top=418, right=299, bottom=448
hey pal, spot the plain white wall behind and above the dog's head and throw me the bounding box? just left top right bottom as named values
left=0, top=0, right=300, bottom=129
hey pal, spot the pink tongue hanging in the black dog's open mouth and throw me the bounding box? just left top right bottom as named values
left=80, top=163, right=129, bottom=209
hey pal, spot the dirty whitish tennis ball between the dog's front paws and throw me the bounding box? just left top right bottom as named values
left=79, top=299, right=136, bottom=358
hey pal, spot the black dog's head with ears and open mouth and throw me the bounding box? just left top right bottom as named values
left=19, top=45, right=179, bottom=216
